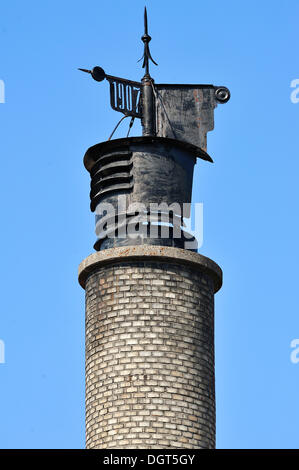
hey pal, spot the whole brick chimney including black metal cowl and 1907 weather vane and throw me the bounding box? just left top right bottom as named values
left=79, top=10, right=230, bottom=449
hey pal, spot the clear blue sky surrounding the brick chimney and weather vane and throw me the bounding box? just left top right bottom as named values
left=0, top=0, right=299, bottom=448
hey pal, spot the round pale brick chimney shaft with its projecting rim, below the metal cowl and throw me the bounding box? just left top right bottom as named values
left=79, top=246, right=221, bottom=449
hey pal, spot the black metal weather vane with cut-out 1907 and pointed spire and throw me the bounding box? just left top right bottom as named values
left=79, top=7, right=230, bottom=153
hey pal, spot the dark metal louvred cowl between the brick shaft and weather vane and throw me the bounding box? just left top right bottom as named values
left=85, top=137, right=202, bottom=250
